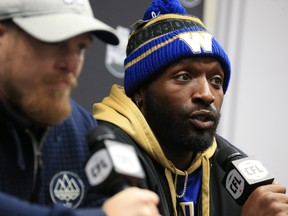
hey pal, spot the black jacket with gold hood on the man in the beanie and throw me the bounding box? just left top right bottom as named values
left=93, top=85, right=245, bottom=216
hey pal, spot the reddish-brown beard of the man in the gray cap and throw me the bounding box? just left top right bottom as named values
left=4, top=74, right=77, bottom=126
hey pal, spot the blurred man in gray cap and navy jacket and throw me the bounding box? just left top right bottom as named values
left=0, top=0, right=159, bottom=216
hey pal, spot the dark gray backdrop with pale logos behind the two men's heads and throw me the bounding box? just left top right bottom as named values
left=72, top=0, right=204, bottom=112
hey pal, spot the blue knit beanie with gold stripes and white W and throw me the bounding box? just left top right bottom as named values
left=124, top=0, right=231, bottom=97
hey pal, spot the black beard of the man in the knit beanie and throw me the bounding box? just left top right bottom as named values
left=143, top=94, right=221, bottom=153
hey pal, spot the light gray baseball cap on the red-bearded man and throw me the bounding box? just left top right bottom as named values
left=0, top=0, right=119, bottom=45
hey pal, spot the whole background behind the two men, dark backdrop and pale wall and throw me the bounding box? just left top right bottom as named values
left=72, top=0, right=288, bottom=187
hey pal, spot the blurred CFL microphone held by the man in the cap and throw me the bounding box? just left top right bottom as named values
left=85, top=126, right=145, bottom=195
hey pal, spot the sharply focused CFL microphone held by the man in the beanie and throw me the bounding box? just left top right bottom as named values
left=217, top=146, right=274, bottom=205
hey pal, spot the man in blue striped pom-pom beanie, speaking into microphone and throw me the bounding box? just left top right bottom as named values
left=93, top=0, right=288, bottom=216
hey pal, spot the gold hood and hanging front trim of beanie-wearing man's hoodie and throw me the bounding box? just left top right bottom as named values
left=93, top=85, right=217, bottom=216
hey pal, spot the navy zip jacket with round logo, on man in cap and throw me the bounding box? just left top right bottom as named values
left=0, top=101, right=105, bottom=216
